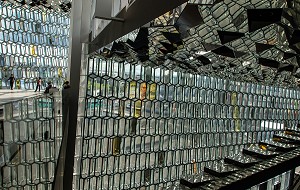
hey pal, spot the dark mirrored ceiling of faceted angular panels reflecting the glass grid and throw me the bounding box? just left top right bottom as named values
left=98, top=0, right=300, bottom=87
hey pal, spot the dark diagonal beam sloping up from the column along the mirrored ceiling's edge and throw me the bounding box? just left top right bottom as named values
left=89, top=0, right=188, bottom=53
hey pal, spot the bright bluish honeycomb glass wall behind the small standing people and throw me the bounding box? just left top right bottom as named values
left=0, top=2, right=70, bottom=89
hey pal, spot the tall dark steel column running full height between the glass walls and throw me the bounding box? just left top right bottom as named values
left=53, top=0, right=85, bottom=190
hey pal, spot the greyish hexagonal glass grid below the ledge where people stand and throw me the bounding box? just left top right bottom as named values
left=0, top=97, right=62, bottom=190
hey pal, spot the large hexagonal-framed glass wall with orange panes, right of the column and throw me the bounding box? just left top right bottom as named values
left=75, top=57, right=300, bottom=190
